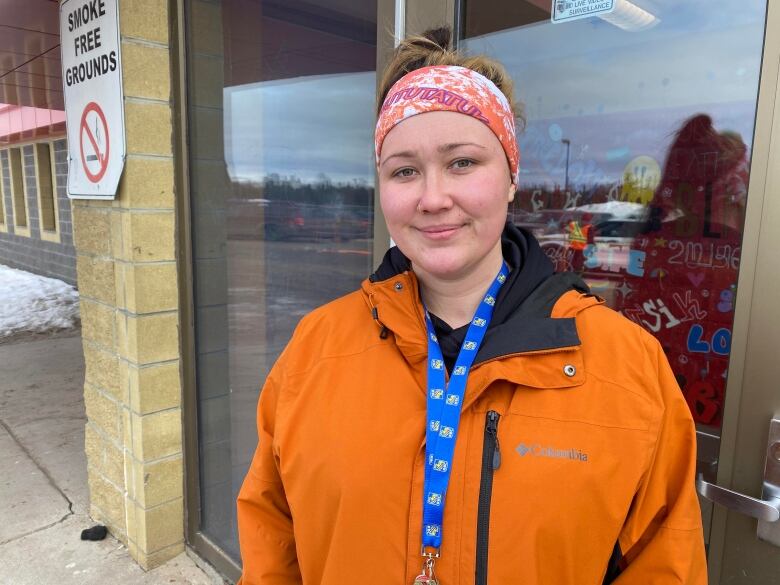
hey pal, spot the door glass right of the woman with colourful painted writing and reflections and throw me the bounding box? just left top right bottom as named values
left=462, top=0, right=766, bottom=429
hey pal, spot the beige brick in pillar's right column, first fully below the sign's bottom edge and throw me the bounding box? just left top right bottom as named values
left=122, top=211, right=176, bottom=262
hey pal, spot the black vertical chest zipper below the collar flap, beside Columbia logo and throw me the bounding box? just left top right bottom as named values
left=475, top=410, right=501, bottom=585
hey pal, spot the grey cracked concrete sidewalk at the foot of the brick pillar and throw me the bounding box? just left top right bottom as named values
left=0, top=332, right=223, bottom=585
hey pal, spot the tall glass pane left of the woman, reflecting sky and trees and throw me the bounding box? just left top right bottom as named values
left=187, top=0, right=376, bottom=560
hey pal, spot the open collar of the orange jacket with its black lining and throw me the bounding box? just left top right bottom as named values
left=362, top=224, right=601, bottom=391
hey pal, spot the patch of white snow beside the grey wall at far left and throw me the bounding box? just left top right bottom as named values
left=0, top=264, right=79, bottom=339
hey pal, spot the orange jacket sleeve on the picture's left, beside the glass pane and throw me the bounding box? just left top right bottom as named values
left=237, top=362, right=302, bottom=585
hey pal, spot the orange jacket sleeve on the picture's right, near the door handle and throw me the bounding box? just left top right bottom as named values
left=613, top=335, right=707, bottom=585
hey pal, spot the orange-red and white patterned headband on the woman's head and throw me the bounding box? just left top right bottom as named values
left=374, top=65, right=520, bottom=185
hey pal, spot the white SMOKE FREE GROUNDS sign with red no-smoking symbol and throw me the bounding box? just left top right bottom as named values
left=60, top=0, right=125, bottom=199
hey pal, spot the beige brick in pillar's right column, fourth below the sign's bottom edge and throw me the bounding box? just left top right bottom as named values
left=128, top=361, right=181, bottom=414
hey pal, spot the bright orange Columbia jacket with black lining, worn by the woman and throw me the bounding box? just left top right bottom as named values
left=238, top=272, right=707, bottom=585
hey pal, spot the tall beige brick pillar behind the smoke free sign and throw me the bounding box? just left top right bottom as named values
left=73, top=0, right=184, bottom=569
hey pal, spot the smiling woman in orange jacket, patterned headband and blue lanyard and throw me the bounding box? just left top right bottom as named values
left=238, top=30, right=706, bottom=585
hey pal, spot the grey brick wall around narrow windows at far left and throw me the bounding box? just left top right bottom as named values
left=0, top=139, right=76, bottom=284
